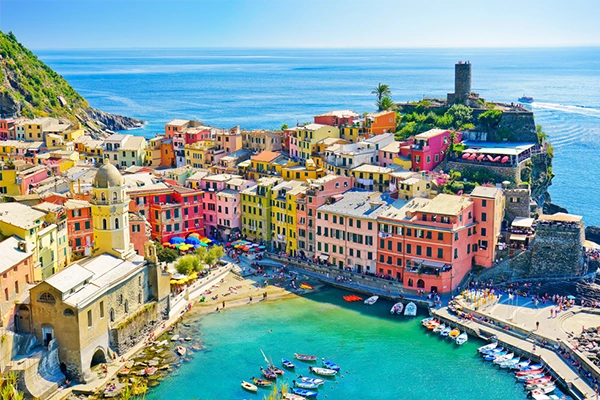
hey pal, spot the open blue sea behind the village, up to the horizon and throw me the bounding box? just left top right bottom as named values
left=36, top=47, right=600, bottom=225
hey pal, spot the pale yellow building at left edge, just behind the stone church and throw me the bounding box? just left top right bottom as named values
left=0, top=203, right=59, bottom=281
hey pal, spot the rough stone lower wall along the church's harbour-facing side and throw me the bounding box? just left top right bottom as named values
left=109, top=302, right=163, bottom=355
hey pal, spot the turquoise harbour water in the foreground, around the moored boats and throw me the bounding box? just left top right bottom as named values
left=147, top=288, right=526, bottom=400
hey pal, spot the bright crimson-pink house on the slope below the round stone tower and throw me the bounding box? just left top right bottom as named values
left=410, top=129, right=462, bottom=172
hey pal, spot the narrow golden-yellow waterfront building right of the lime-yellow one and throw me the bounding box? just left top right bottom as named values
left=271, top=181, right=308, bottom=256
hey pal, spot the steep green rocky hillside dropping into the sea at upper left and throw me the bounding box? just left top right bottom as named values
left=0, top=31, right=143, bottom=132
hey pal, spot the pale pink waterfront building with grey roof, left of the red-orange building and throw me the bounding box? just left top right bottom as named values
left=316, top=190, right=392, bottom=273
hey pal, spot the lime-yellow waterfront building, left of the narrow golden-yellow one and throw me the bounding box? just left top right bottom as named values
left=240, top=177, right=281, bottom=242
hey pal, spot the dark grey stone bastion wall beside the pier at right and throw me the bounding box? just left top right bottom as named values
left=528, top=223, right=584, bottom=277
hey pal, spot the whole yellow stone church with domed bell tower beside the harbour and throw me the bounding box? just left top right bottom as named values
left=26, top=162, right=170, bottom=382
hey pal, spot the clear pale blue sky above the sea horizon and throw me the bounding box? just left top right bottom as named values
left=0, top=0, right=600, bottom=49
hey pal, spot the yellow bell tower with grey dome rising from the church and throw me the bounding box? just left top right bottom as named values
left=90, top=159, right=135, bottom=259
